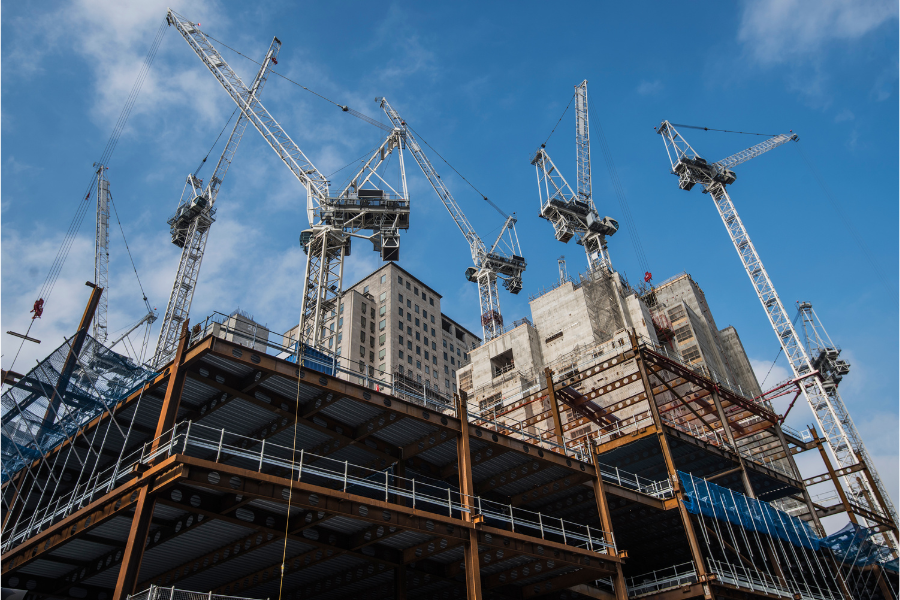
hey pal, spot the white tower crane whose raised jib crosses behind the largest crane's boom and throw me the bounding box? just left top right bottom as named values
left=152, top=38, right=281, bottom=367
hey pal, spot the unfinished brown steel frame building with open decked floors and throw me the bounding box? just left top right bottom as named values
left=0, top=316, right=897, bottom=600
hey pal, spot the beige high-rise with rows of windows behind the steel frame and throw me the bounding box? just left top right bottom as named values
left=284, top=262, right=481, bottom=403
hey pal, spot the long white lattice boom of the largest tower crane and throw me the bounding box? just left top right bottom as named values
left=166, top=9, right=328, bottom=224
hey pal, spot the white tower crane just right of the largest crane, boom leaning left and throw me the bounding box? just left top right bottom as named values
left=381, top=98, right=526, bottom=342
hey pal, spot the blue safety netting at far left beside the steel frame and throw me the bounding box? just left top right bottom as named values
left=0, top=336, right=156, bottom=482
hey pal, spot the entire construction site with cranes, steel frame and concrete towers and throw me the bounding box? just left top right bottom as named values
left=0, top=10, right=900, bottom=600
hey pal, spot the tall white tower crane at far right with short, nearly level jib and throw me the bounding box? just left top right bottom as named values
left=657, top=121, right=898, bottom=534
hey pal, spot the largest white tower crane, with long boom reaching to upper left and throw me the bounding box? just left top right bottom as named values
left=166, top=10, right=409, bottom=348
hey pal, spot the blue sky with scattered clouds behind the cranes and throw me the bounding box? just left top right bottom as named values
left=0, top=0, right=900, bottom=520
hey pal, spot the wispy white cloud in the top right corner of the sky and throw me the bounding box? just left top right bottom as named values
left=738, top=0, right=898, bottom=65
